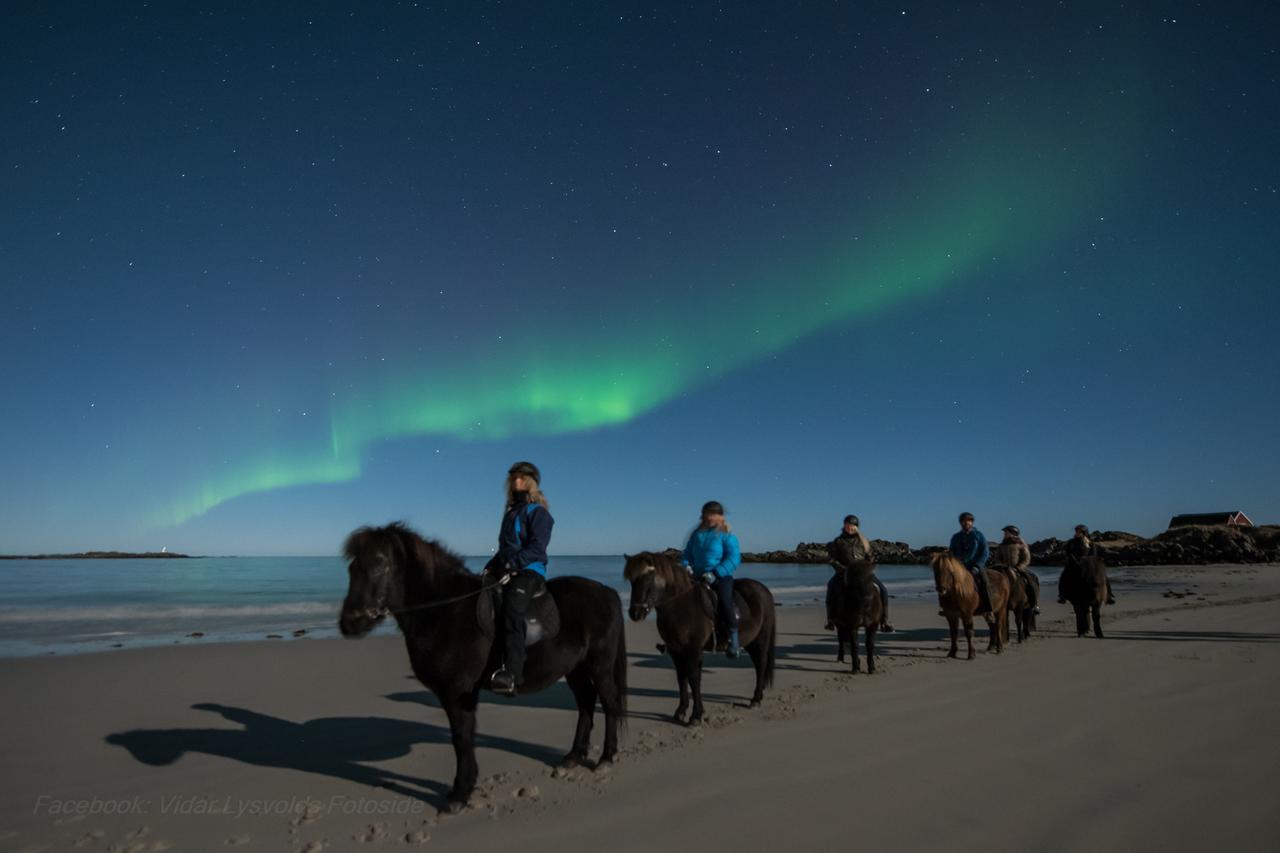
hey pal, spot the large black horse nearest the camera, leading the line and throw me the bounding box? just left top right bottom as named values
left=338, top=523, right=627, bottom=813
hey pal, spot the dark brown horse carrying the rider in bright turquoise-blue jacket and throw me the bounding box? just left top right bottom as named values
left=622, top=551, right=778, bottom=725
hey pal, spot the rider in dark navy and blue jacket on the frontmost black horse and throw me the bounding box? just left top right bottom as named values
left=485, top=462, right=556, bottom=695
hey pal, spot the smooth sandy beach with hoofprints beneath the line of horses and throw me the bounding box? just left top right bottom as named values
left=0, top=566, right=1280, bottom=853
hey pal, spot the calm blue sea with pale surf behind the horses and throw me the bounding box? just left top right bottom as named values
left=0, top=556, right=1054, bottom=657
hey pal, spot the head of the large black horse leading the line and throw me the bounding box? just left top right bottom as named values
left=338, top=524, right=408, bottom=638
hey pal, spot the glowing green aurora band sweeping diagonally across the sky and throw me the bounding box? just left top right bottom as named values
left=152, top=108, right=1133, bottom=525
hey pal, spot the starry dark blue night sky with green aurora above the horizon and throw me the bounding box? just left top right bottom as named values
left=0, top=1, right=1280, bottom=555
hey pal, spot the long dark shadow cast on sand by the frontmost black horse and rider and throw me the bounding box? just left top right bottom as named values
left=105, top=702, right=561, bottom=808
